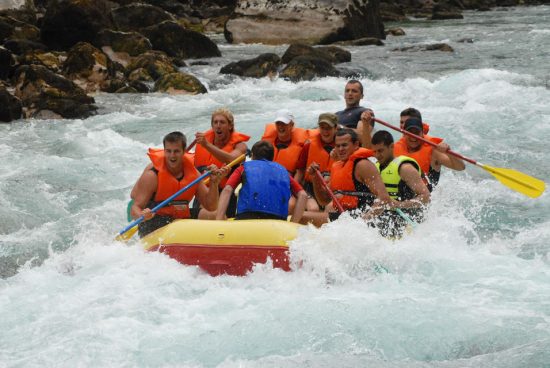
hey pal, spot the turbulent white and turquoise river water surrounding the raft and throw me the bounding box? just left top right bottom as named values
left=0, top=6, right=550, bottom=368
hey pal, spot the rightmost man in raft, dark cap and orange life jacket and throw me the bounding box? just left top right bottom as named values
left=393, top=117, right=465, bottom=189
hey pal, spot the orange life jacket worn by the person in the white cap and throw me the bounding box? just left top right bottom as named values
left=262, top=124, right=308, bottom=175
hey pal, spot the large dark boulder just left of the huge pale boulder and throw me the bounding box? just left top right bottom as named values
left=142, top=21, right=221, bottom=59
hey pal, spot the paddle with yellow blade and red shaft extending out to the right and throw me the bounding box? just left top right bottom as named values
left=374, top=118, right=546, bottom=198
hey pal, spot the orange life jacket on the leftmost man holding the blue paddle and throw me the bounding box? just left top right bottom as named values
left=148, top=148, right=200, bottom=218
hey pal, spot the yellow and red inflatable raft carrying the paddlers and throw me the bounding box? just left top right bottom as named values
left=141, top=220, right=300, bottom=276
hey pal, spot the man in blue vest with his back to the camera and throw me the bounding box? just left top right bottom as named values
left=216, top=141, right=307, bottom=222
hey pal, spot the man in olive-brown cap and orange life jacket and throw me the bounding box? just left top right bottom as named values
left=295, top=113, right=338, bottom=211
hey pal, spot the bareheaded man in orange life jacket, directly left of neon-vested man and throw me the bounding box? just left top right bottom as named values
left=302, top=129, right=392, bottom=226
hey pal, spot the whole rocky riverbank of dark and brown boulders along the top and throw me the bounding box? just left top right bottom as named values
left=0, top=0, right=550, bottom=122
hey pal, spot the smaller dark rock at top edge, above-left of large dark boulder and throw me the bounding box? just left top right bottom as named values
left=113, top=3, right=176, bottom=31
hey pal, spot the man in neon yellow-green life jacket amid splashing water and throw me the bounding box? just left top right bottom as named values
left=372, top=130, right=430, bottom=236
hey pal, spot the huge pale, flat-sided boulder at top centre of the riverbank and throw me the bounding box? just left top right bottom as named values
left=224, top=0, right=385, bottom=44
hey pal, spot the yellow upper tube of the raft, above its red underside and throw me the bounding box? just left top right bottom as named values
left=141, top=219, right=300, bottom=250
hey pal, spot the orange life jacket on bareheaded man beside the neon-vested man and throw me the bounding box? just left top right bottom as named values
left=330, top=148, right=374, bottom=210
